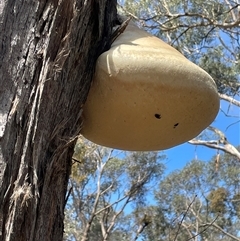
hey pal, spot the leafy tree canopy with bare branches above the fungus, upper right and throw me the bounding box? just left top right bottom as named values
left=120, top=0, right=240, bottom=95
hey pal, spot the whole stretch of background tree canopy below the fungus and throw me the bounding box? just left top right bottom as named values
left=65, top=142, right=240, bottom=241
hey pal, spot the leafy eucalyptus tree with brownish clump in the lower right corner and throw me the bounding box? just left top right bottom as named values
left=143, top=154, right=240, bottom=241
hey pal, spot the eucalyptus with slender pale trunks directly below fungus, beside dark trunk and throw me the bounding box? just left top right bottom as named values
left=65, top=139, right=164, bottom=241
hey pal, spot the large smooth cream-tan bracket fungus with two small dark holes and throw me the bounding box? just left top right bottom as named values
left=82, top=22, right=219, bottom=151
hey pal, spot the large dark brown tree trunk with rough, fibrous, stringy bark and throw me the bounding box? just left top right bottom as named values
left=0, top=0, right=116, bottom=241
